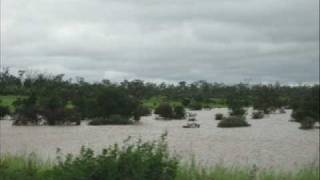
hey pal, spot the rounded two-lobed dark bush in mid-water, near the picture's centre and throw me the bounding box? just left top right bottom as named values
left=154, top=103, right=186, bottom=119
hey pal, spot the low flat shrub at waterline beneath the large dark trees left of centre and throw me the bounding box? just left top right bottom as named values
left=89, top=114, right=133, bottom=126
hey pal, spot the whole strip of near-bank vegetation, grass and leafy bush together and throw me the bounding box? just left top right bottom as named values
left=0, top=134, right=319, bottom=180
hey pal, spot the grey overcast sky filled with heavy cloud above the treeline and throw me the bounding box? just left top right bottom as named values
left=1, top=0, right=319, bottom=83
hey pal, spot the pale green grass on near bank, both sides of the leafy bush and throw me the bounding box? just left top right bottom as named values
left=0, top=154, right=319, bottom=180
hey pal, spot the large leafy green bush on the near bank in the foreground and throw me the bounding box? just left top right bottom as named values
left=48, top=134, right=179, bottom=180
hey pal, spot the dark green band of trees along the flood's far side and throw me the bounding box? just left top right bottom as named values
left=0, top=69, right=319, bottom=128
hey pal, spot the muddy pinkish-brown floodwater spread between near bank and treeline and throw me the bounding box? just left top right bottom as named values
left=0, top=108, right=319, bottom=170
